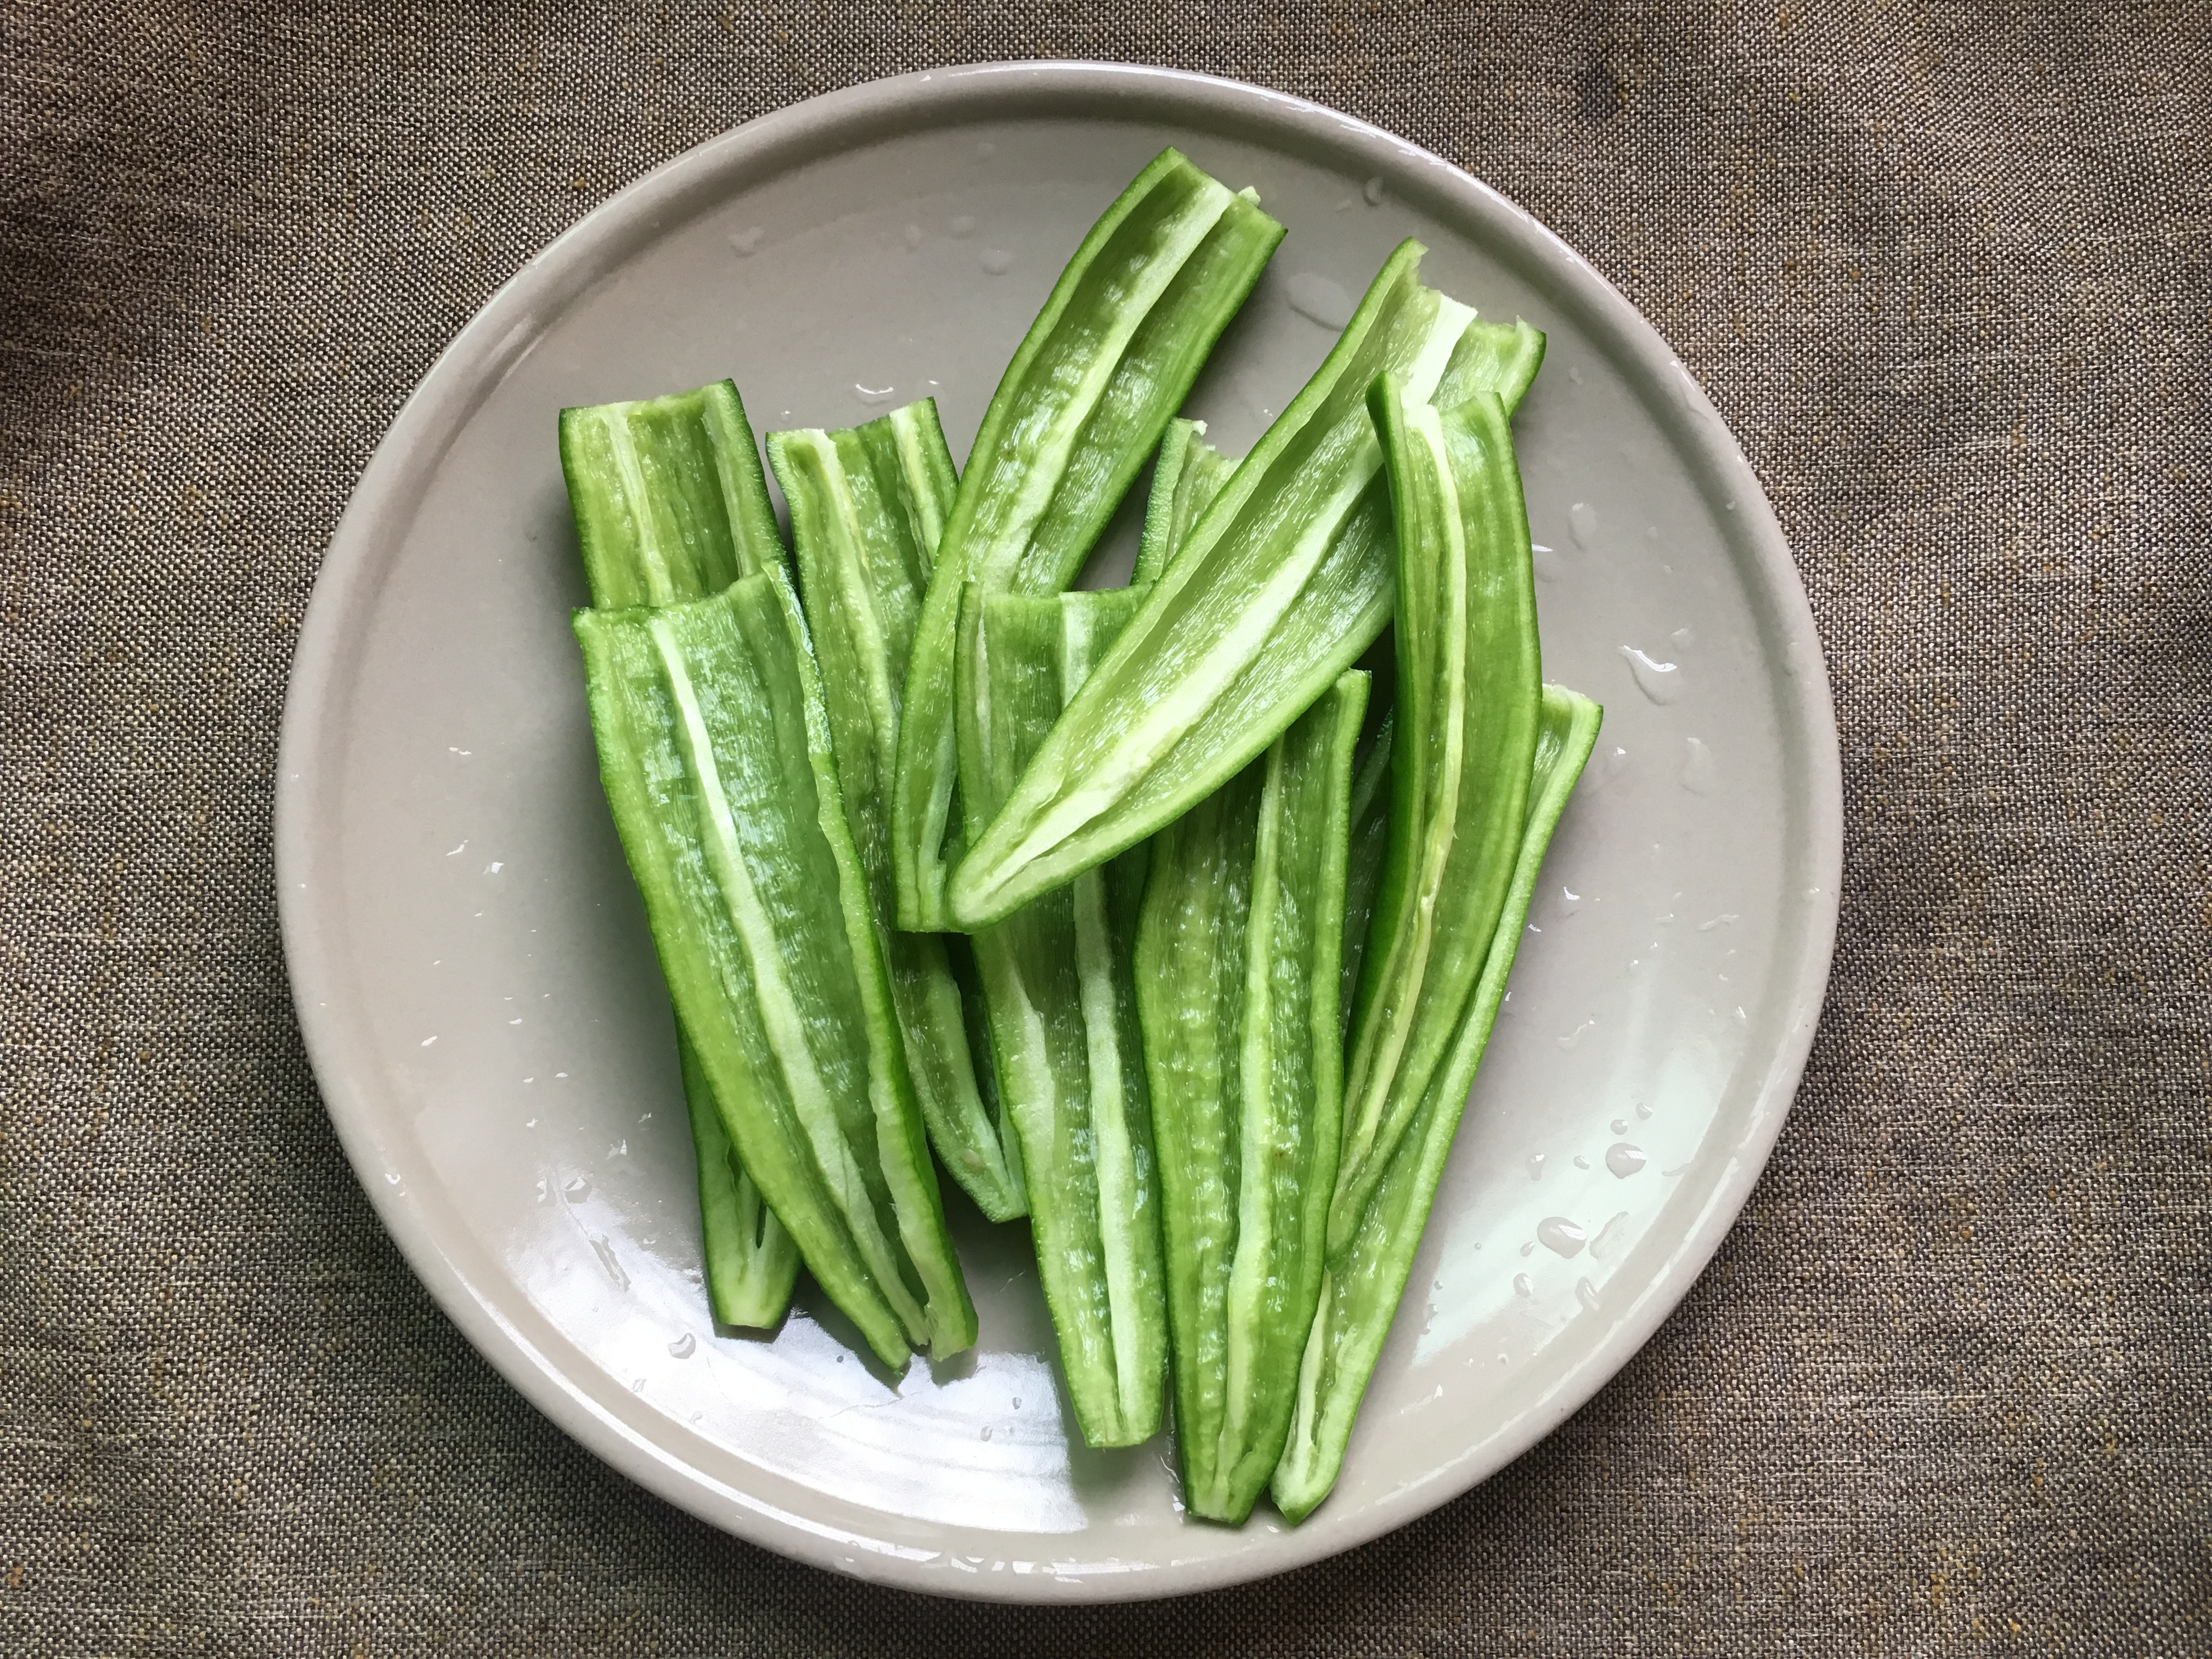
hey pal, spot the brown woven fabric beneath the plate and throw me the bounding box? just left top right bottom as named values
left=0, top=0, right=2212, bottom=1655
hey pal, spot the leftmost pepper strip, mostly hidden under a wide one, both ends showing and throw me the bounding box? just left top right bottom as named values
left=560, top=381, right=799, bottom=1325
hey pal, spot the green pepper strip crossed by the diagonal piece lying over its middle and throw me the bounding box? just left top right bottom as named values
left=960, top=586, right=1168, bottom=1447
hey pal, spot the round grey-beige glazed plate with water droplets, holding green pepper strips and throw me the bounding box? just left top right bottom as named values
left=276, top=64, right=1841, bottom=1601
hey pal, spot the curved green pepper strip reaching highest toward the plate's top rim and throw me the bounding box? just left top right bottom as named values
left=891, top=150, right=1283, bottom=931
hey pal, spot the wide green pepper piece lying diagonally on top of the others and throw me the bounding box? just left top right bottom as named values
left=947, top=241, right=1544, bottom=929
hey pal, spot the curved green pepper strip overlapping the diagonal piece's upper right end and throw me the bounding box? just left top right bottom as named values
left=1329, top=378, right=1544, bottom=1256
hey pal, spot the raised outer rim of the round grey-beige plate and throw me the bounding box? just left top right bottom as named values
left=272, top=62, right=1843, bottom=1604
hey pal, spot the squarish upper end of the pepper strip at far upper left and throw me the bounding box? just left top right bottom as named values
left=560, top=381, right=783, bottom=611
